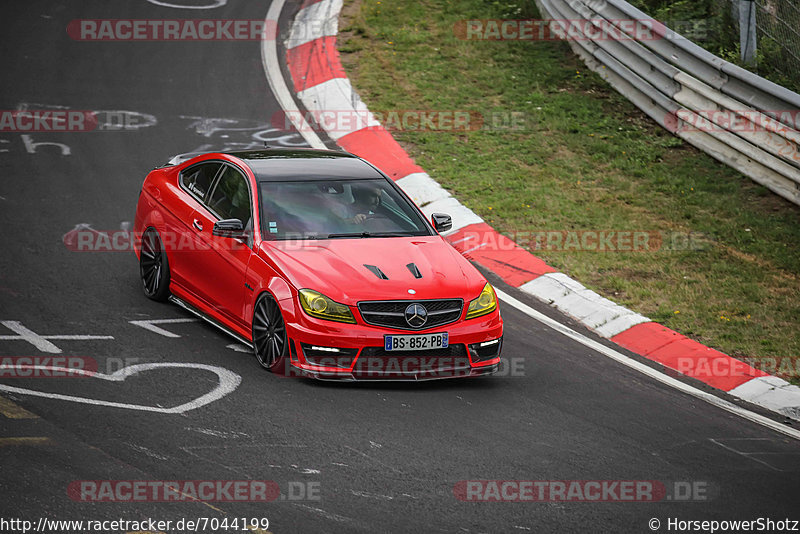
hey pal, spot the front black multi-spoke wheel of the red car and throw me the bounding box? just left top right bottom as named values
left=253, top=293, right=289, bottom=374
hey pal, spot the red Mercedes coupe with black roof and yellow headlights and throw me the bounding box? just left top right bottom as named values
left=134, top=148, right=503, bottom=380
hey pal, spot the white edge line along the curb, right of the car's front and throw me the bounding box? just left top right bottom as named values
left=495, top=288, right=800, bottom=440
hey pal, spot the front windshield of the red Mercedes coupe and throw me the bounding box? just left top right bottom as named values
left=260, top=179, right=431, bottom=240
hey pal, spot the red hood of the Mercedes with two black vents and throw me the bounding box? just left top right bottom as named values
left=261, top=236, right=486, bottom=305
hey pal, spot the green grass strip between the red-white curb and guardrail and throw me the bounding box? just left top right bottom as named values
left=339, top=0, right=800, bottom=382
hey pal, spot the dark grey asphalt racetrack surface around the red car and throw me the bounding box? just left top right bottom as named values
left=0, top=0, right=800, bottom=533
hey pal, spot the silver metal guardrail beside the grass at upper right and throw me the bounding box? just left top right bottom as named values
left=536, top=0, right=800, bottom=205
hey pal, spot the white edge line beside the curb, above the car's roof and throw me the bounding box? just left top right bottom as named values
left=261, top=0, right=327, bottom=148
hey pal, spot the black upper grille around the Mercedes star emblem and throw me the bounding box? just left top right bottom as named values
left=358, top=299, right=464, bottom=330
